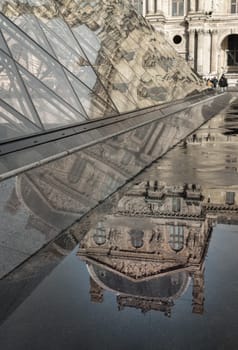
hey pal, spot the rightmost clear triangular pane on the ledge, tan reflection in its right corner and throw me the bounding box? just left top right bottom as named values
left=67, top=72, right=116, bottom=119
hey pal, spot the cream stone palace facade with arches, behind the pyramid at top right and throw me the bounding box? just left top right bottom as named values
left=137, top=0, right=238, bottom=81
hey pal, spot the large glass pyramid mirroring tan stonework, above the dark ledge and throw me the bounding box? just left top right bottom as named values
left=0, top=0, right=204, bottom=143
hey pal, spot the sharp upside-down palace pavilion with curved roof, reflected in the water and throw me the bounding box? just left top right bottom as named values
left=78, top=181, right=218, bottom=316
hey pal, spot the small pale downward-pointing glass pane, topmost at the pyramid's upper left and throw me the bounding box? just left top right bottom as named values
left=13, top=14, right=54, bottom=55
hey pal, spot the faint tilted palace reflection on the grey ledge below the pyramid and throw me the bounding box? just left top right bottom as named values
left=7, top=123, right=173, bottom=232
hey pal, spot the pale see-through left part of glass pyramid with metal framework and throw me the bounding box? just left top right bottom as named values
left=0, top=13, right=118, bottom=142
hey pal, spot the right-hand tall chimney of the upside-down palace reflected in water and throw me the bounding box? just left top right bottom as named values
left=192, top=267, right=204, bottom=315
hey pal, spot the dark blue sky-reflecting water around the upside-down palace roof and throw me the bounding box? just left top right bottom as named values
left=0, top=225, right=238, bottom=350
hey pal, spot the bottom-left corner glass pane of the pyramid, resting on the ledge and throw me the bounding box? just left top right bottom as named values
left=0, top=100, right=40, bottom=142
